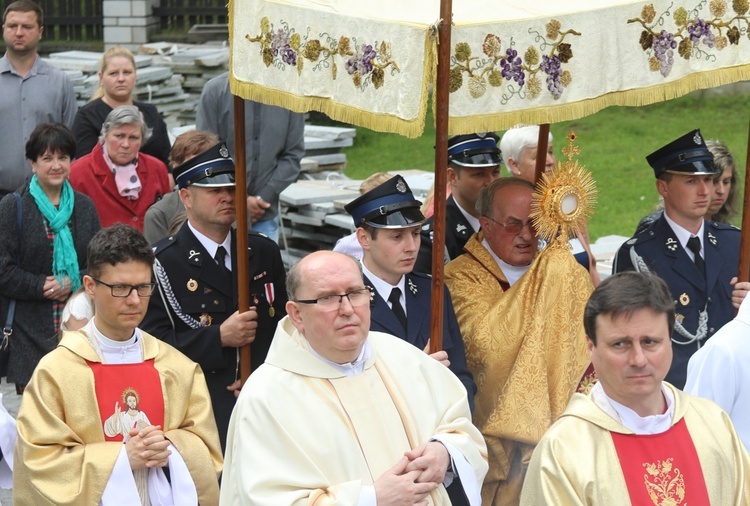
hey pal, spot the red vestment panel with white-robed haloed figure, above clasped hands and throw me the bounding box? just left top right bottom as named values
left=87, top=359, right=164, bottom=441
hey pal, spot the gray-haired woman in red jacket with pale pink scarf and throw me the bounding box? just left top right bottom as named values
left=70, top=105, right=171, bottom=231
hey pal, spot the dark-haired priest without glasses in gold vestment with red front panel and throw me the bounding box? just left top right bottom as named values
left=521, top=271, right=750, bottom=506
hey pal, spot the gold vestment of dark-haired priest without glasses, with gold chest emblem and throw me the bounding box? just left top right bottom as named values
left=521, top=383, right=750, bottom=506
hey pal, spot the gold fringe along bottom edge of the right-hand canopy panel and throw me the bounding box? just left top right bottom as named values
left=448, top=65, right=750, bottom=135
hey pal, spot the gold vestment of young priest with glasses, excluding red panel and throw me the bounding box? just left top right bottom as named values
left=13, top=332, right=222, bottom=506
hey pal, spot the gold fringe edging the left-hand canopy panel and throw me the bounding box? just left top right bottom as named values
left=229, top=0, right=437, bottom=139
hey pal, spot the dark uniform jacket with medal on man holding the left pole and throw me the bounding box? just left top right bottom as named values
left=141, top=223, right=287, bottom=449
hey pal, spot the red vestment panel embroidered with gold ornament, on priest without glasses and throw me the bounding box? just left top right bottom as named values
left=610, top=419, right=710, bottom=506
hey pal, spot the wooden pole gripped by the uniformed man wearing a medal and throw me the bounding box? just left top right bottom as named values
left=234, top=95, right=250, bottom=385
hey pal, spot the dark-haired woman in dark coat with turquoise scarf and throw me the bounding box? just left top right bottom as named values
left=0, top=123, right=99, bottom=393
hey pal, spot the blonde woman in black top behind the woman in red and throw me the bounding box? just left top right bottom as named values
left=73, top=46, right=170, bottom=165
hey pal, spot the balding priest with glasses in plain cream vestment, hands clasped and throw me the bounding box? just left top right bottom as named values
left=220, top=251, right=487, bottom=506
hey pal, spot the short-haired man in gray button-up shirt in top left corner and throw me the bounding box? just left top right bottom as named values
left=0, top=0, right=78, bottom=197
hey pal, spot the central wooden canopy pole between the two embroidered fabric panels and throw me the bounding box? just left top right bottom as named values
left=430, top=0, right=453, bottom=353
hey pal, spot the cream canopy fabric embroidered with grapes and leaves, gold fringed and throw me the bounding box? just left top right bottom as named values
left=229, top=0, right=750, bottom=137
